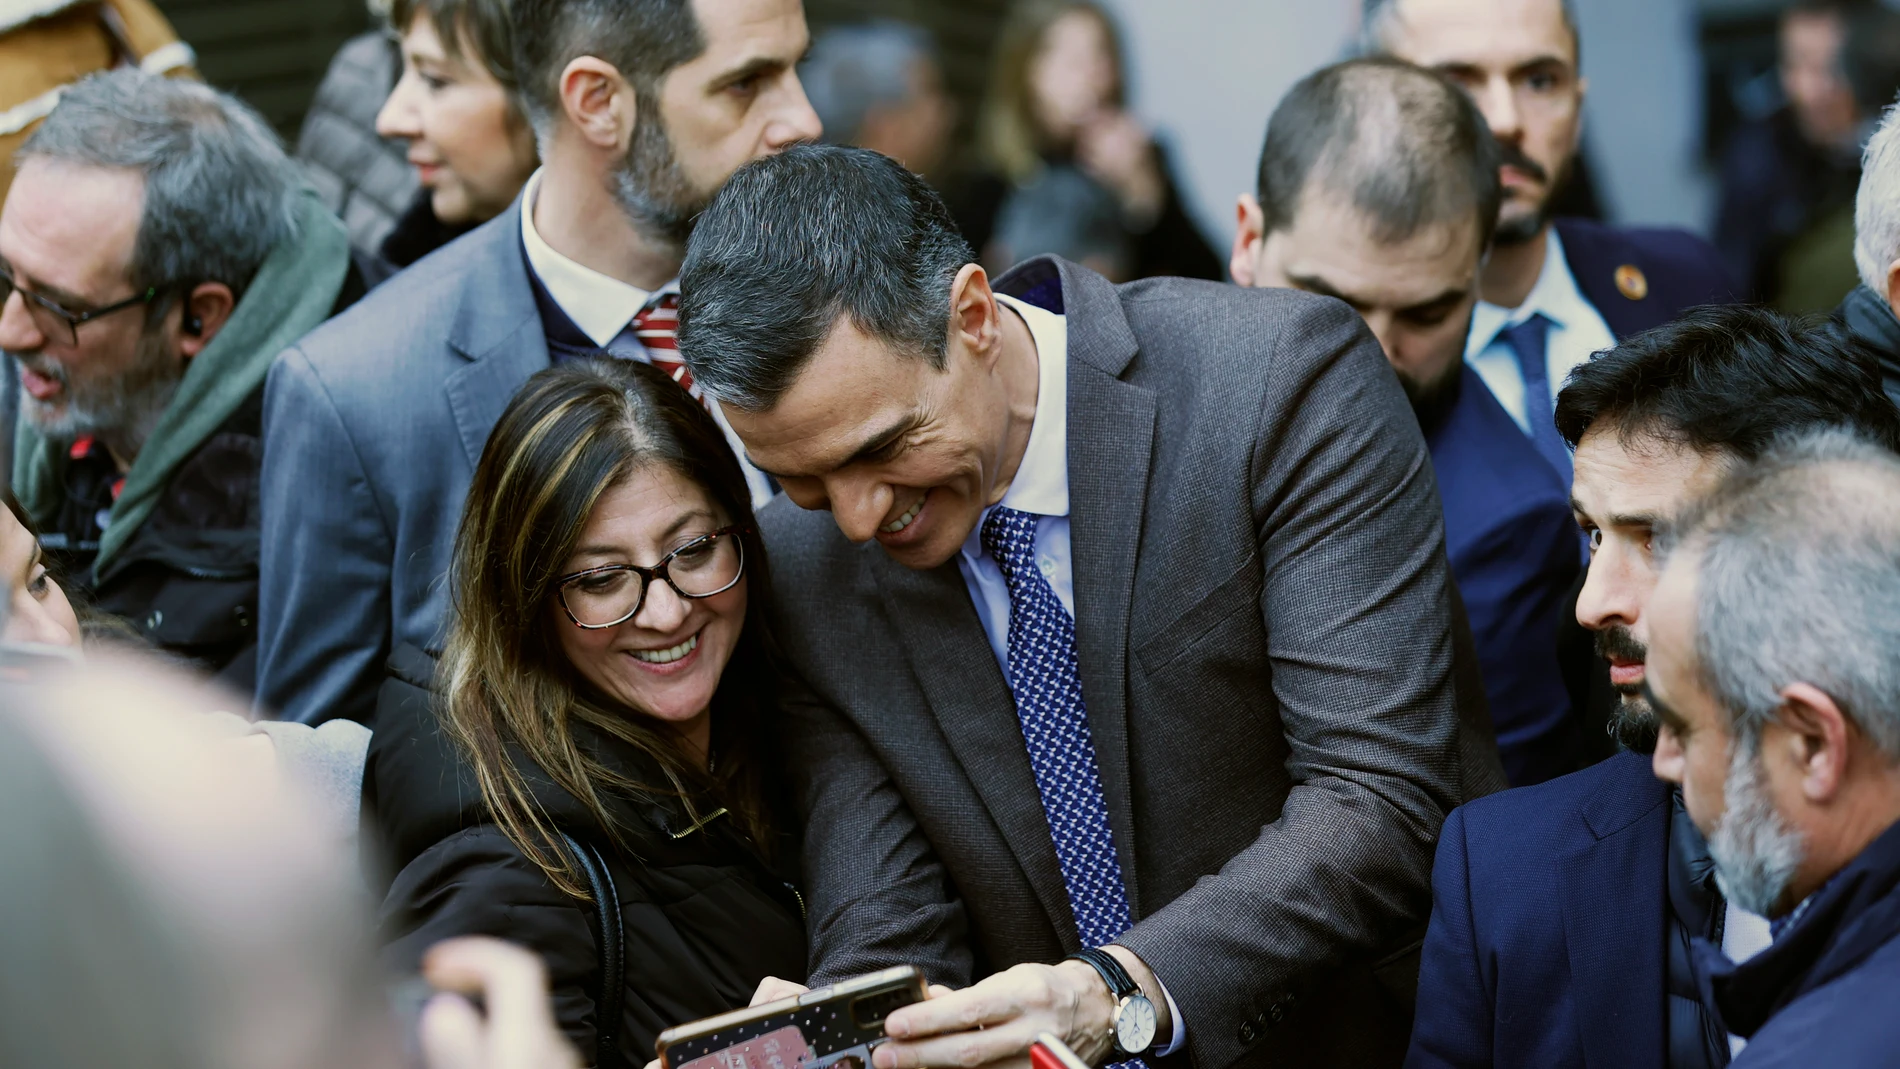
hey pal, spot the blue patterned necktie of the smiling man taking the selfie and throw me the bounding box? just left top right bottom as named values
left=982, top=507, right=1132, bottom=946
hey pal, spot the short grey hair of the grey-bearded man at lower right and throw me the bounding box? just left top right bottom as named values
left=1661, top=429, right=1900, bottom=761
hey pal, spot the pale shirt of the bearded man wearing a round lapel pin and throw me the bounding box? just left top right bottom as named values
left=1465, top=226, right=1617, bottom=435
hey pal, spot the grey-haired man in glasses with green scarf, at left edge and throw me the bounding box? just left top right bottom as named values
left=0, top=70, right=361, bottom=689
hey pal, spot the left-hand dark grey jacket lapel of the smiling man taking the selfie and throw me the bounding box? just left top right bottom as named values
left=865, top=549, right=1075, bottom=944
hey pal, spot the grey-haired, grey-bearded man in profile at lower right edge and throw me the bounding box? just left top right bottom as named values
left=1645, top=431, right=1900, bottom=1069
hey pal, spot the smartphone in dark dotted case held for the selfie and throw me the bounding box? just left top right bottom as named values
left=656, top=965, right=925, bottom=1069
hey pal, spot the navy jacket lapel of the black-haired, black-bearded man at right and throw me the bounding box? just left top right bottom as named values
left=1558, top=754, right=1670, bottom=1069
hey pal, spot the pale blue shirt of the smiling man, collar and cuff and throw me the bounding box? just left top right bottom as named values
left=956, top=294, right=1188, bottom=1058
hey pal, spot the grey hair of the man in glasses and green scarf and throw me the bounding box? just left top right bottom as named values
left=19, top=68, right=302, bottom=305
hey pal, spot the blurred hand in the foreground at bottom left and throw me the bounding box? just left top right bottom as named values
left=418, top=936, right=581, bottom=1069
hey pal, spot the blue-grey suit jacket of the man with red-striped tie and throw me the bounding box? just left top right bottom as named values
left=257, top=197, right=547, bottom=723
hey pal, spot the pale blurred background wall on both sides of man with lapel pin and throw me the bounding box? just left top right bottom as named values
left=1106, top=0, right=1708, bottom=258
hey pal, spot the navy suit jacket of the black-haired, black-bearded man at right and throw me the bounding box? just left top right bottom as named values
left=1406, top=754, right=1670, bottom=1069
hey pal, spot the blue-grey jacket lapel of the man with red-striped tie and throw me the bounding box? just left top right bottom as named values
left=447, top=197, right=547, bottom=465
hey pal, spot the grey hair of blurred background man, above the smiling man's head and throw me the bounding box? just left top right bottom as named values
left=798, top=19, right=937, bottom=144
